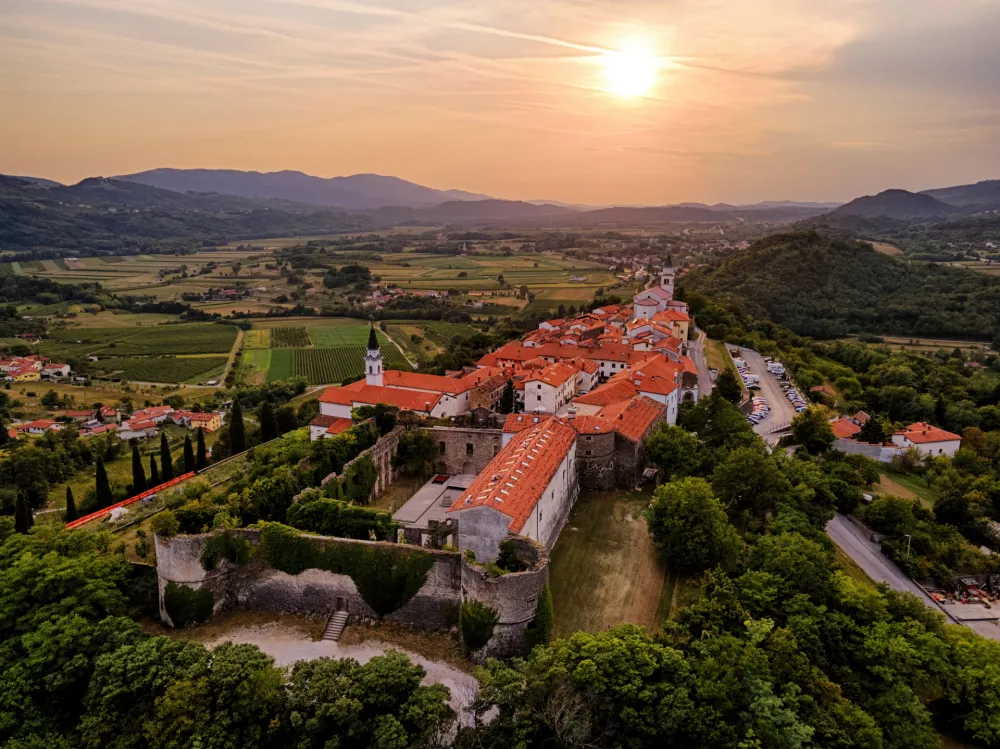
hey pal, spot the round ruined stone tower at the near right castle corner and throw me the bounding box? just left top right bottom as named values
left=462, top=536, right=549, bottom=663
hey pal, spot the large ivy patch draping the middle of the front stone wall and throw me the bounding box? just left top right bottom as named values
left=259, top=523, right=434, bottom=616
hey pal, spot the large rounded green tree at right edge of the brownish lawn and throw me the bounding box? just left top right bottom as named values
left=649, top=478, right=740, bottom=572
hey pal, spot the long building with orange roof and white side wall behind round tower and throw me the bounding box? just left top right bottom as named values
left=448, top=418, right=579, bottom=562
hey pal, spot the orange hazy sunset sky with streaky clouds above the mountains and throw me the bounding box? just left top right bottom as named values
left=0, top=0, right=1000, bottom=205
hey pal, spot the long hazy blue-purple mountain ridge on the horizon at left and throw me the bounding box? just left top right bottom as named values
left=116, top=169, right=489, bottom=210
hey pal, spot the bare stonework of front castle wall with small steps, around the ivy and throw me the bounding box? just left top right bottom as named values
left=155, top=529, right=461, bottom=629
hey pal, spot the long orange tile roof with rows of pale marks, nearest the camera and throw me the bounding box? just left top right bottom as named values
left=448, top=419, right=576, bottom=533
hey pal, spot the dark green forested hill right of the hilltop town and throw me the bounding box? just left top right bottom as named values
left=683, top=231, right=1000, bottom=340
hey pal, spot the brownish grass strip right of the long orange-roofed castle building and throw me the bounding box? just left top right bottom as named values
left=549, top=491, right=666, bottom=637
